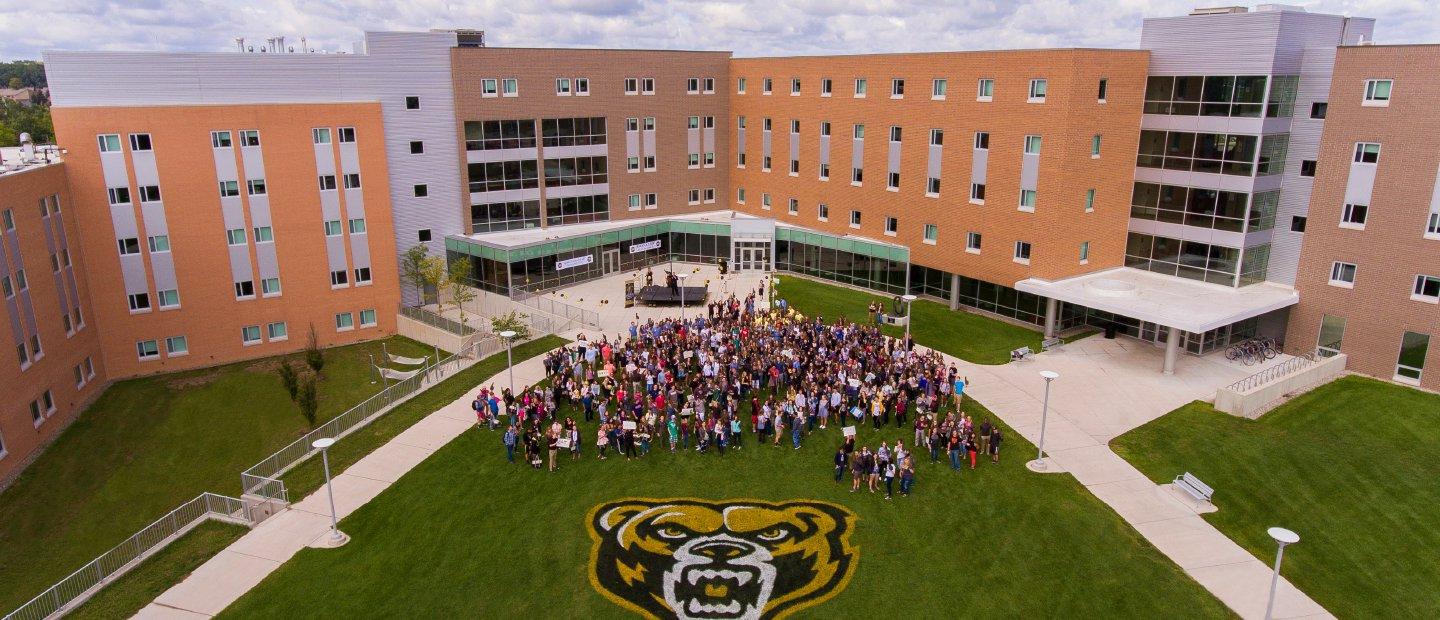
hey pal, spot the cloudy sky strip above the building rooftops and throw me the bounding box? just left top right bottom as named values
left=0, top=0, right=1440, bottom=60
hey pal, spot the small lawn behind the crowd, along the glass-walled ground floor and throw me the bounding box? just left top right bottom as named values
left=776, top=276, right=1041, bottom=364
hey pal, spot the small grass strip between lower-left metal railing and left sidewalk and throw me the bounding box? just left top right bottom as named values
left=66, top=521, right=249, bottom=620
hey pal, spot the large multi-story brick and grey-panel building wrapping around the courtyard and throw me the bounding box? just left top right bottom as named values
left=8, top=6, right=1440, bottom=473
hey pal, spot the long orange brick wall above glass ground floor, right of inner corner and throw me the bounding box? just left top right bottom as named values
left=726, top=50, right=1149, bottom=286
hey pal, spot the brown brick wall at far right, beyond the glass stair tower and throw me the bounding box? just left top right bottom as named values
left=1286, top=45, right=1440, bottom=390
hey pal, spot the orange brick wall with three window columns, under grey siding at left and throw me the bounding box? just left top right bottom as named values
left=53, top=104, right=399, bottom=378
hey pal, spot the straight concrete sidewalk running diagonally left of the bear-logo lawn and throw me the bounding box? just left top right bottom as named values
left=135, top=339, right=561, bottom=619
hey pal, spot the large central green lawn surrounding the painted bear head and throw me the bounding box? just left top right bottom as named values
left=223, top=404, right=1230, bottom=619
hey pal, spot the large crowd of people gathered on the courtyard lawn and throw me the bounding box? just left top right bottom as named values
left=474, top=289, right=1004, bottom=499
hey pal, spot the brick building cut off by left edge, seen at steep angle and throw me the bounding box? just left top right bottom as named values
left=0, top=150, right=107, bottom=486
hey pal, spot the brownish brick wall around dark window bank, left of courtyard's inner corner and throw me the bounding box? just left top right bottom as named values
left=451, top=47, right=733, bottom=230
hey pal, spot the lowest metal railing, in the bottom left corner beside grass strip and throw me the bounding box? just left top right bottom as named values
left=4, top=493, right=251, bottom=620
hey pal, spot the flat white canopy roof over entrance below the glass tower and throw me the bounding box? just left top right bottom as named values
left=1015, top=268, right=1300, bottom=334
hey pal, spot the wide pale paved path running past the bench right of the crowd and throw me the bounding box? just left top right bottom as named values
left=927, top=337, right=1333, bottom=619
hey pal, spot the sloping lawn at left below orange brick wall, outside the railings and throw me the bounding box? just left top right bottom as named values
left=0, top=338, right=432, bottom=610
